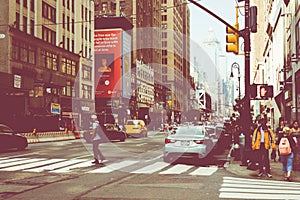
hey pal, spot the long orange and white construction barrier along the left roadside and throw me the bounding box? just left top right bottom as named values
left=19, top=131, right=80, bottom=143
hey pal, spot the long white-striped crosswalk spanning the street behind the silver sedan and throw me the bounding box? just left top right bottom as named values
left=0, top=157, right=218, bottom=176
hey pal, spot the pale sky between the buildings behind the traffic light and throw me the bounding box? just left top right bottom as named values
left=189, top=0, right=244, bottom=96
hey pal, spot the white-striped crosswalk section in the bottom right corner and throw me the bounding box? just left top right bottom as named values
left=219, top=177, right=300, bottom=200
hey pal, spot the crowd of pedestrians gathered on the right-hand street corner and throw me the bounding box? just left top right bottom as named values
left=232, top=114, right=300, bottom=181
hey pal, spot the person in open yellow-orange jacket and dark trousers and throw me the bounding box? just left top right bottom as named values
left=252, top=117, right=276, bottom=178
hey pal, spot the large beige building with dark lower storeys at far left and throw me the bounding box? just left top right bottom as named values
left=0, top=0, right=94, bottom=131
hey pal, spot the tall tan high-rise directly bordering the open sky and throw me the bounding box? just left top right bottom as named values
left=161, top=0, right=190, bottom=123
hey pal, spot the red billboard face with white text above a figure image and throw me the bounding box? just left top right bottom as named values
left=94, top=29, right=122, bottom=98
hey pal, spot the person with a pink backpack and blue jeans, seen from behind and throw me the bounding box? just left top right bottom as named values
left=278, top=127, right=296, bottom=181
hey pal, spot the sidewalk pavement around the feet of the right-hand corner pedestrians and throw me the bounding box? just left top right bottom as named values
left=226, top=150, right=300, bottom=182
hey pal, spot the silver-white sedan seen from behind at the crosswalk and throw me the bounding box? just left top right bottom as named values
left=163, top=126, right=214, bottom=163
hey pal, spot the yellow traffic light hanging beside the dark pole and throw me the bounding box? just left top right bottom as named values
left=226, top=24, right=239, bottom=54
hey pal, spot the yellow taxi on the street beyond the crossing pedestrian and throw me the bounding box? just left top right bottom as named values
left=125, top=120, right=148, bottom=137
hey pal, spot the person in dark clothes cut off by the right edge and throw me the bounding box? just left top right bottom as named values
left=291, top=120, right=300, bottom=171
